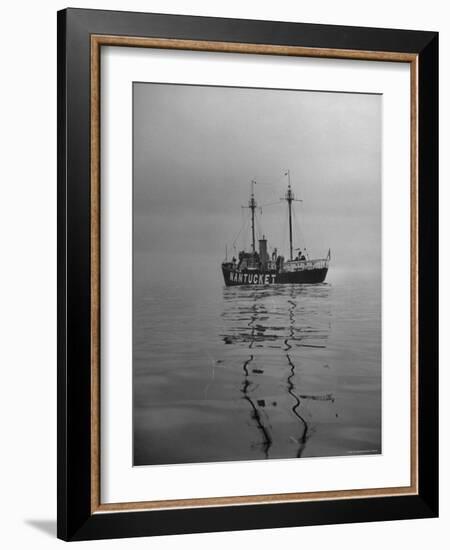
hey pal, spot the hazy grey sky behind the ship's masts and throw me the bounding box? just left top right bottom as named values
left=133, top=83, right=382, bottom=283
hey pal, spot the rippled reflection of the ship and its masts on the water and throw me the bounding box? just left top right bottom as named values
left=221, top=284, right=334, bottom=458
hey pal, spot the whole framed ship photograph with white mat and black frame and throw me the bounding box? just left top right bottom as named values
left=58, top=9, right=438, bottom=540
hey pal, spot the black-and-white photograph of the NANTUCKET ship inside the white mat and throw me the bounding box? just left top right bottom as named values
left=133, top=82, right=383, bottom=466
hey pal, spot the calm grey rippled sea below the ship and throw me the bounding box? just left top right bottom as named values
left=133, top=276, right=381, bottom=465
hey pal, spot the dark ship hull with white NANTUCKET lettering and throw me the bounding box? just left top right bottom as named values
left=222, top=266, right=328, bottom=286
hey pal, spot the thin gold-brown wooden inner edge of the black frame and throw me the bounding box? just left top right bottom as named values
left=90, top=34, right=419, bottom=514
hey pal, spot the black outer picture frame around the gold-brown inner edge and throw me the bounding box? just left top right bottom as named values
left=57, top=9, right=438, bottom=540
